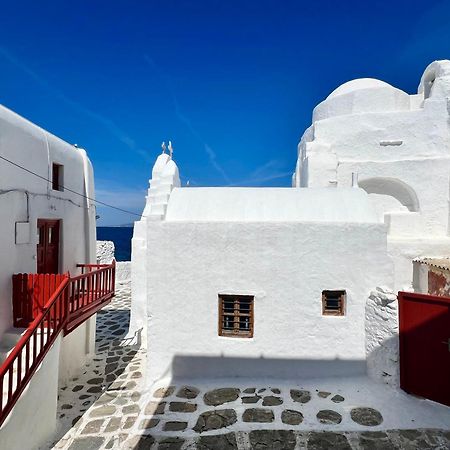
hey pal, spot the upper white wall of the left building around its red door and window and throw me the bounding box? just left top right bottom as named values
left=0, top=106, right=96, bottom=339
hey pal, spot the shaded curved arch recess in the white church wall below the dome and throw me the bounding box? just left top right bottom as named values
left=359, top=177, right=420, bottom=212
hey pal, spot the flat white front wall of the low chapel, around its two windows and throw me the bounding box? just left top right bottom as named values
left=145, top=221, right=393, bottom=380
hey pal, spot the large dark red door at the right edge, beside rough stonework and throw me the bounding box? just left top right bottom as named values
left=399, top=292, right=450, bottom=406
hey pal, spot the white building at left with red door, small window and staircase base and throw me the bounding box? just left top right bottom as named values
left=0, top=106, right=96, bottom=450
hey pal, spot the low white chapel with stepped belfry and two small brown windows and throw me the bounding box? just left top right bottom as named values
left=132, top=154, right=393, bottom=380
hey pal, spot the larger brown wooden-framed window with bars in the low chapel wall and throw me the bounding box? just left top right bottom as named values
left=219, top=295, right=254, bottom=338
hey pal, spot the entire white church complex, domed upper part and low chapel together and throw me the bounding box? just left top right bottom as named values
left=131, top=61, right=450, bottom=385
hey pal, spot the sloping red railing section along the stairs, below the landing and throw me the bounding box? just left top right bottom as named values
left=0, top=275, right=69, bottom=425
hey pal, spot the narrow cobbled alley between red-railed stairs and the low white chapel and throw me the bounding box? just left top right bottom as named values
left=44, top=283, right=145, bottom=450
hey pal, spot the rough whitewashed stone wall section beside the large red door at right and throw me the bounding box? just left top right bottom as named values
left=365, top=287, right=399, bottom=387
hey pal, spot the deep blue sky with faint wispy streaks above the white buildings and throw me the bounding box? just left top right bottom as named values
left=0, top=0, right=450, bottom=225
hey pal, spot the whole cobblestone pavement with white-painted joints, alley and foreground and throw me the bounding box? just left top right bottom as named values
left=46, top=284, right=450, bottom=450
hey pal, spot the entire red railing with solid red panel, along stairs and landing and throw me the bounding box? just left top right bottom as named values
left=0, top=261, right=116, bottom=426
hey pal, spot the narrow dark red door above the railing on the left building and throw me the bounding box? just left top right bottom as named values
left=37, top=219, right=60, bottom=273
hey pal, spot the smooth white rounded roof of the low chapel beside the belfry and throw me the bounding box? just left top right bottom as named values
left=166, top=187, right=379, bottom=223
